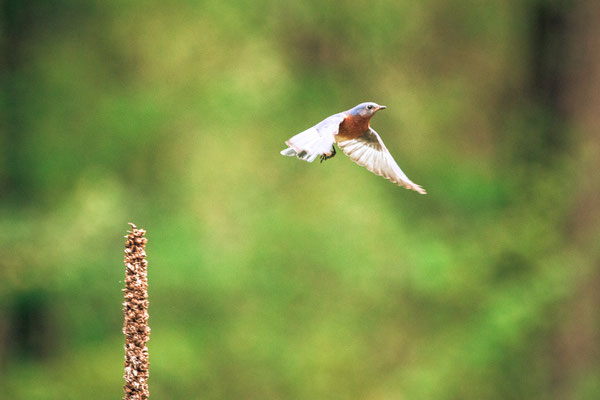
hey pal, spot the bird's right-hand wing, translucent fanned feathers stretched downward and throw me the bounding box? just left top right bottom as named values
left=338, top=128, right=426, bottom=194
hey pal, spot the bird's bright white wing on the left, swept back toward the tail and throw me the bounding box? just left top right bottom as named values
left=281, top=113, right=346, bottom=162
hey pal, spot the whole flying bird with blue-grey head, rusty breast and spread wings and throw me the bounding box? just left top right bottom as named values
left=281, top=102, right=427, bottom=194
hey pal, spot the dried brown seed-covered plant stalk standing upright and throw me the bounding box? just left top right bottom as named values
left=123, top=223, right=150, bottom=400
